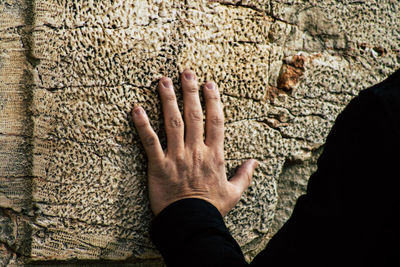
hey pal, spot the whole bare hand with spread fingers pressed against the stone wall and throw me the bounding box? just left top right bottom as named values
left=132, top=70, right=258, bottom=216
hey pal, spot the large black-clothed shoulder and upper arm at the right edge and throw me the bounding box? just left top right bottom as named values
left=252, top=71, right=400, bottom=266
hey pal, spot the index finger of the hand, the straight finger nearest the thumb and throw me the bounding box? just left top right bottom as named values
left=203, top=82, right=224, bottom=149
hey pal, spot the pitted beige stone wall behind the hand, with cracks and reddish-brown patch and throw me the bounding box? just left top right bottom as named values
left=0, top=0, right=400, bottom=266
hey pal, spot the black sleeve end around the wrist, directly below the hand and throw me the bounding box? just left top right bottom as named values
left=150, top=198, right=248, bottom=267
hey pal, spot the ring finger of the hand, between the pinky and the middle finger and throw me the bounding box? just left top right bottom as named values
left=158, top=77, right=184, bottom=155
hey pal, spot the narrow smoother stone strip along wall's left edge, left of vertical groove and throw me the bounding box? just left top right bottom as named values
left=0, top=0, right=38, bottom=266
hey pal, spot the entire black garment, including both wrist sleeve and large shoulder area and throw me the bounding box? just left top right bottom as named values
left=150, top=70, right=400, bottom=266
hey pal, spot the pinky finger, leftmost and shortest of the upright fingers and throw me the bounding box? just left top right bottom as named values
left=132, top=107, right=164, bottom=161
